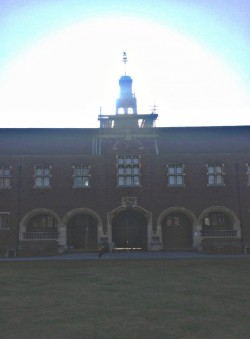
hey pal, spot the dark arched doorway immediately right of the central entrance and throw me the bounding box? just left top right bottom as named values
left=162, top=211, right=193, bottom=250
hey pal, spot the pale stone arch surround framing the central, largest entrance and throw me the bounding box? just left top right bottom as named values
left=107, top=205, right=153, bottom=249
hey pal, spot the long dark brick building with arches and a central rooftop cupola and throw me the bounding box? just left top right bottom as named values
left=0, top=69, right=250, bottom=256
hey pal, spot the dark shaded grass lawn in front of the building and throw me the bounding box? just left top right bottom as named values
left=0, top=258, right=250, bottom=339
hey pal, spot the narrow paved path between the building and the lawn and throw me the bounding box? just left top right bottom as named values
left=0, top=252, right=250, bottom=262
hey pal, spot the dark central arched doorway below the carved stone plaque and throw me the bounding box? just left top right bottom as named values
left=112, top=209, right=147, bottom=250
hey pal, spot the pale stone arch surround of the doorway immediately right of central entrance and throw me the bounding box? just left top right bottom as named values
left=157, top=206, right=200, bottom=248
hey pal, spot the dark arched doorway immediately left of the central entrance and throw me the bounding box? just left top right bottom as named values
left=67, top=213, right=98, bottom=250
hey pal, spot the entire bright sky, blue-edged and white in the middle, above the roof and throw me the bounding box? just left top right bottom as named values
left=0, top=0, right=250, bottom=128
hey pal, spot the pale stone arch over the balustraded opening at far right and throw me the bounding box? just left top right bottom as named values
left=197, top=206, right=241, bottom=238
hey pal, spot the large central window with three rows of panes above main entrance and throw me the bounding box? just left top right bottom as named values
left=117, top=155, right=141, bottom=187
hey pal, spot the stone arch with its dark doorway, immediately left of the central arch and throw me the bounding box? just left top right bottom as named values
left=62, top=207, right=105, bottom=250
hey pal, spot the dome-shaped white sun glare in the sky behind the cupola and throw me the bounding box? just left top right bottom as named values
left=0, top=18, right=250, bottom=127
